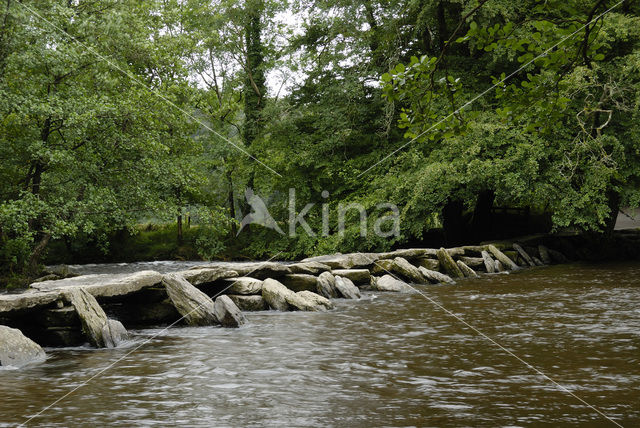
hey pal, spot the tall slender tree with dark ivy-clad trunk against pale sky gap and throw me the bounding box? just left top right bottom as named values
left=184, top=0, right=286, bottom=244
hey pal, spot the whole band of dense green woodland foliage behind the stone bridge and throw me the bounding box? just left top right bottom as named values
left=0, top=0, right=640, bottom=284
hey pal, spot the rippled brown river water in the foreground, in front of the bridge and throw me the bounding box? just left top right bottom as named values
left=0, top=263, right=640, bottom=427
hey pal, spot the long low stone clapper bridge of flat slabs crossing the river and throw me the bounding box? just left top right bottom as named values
left=0, top=243, right=567, bottom=365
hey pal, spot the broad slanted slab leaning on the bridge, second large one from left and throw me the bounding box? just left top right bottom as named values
left=162, top=273, right=218, bottom=326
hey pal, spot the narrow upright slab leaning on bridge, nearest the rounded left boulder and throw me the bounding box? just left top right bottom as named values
left=65, top=287, right=109, bottom=348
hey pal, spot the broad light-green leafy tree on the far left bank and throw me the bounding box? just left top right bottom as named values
left=0, top=1, right=198, bottom=274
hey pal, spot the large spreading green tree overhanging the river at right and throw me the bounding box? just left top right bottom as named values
left=379, top=1, right=640, bottom=239
